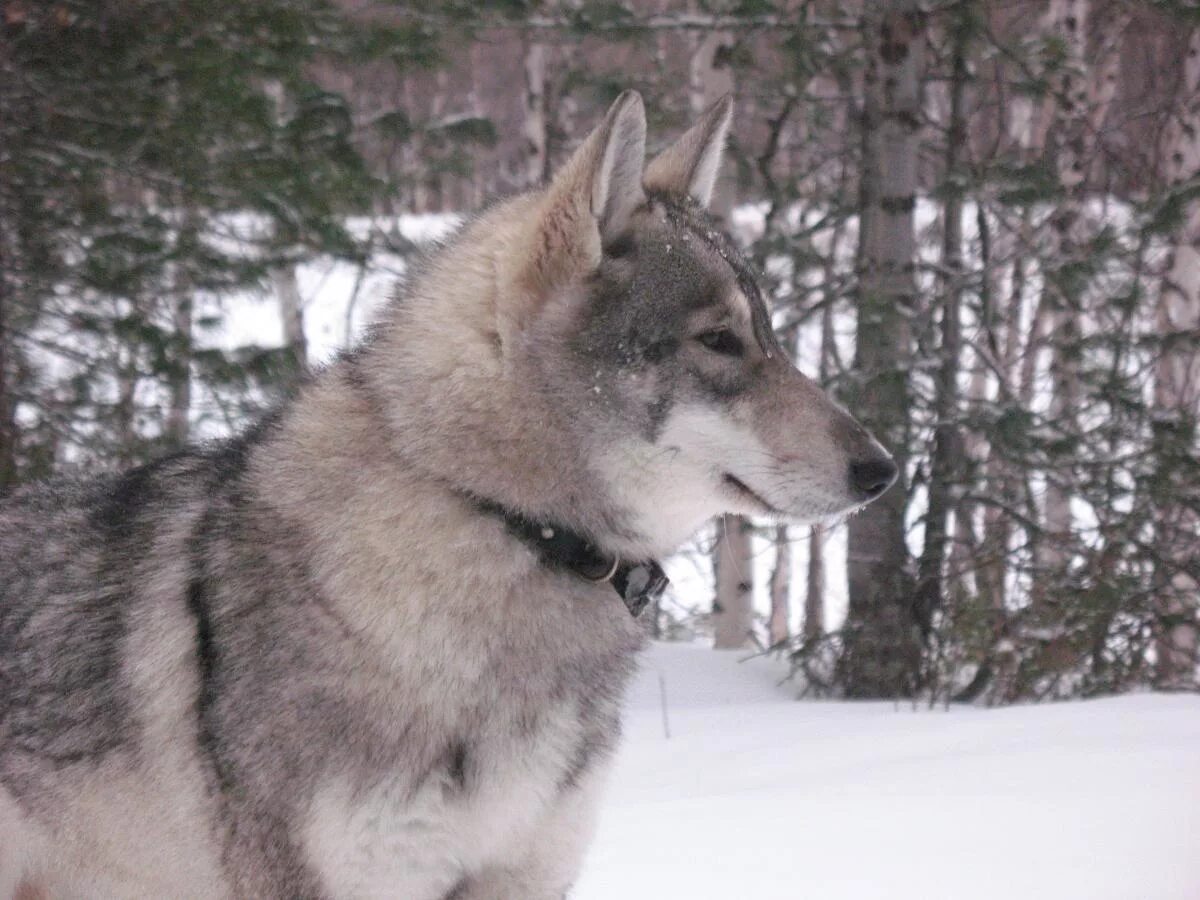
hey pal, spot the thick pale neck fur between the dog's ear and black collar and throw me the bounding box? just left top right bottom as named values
left=350, top=210, right=673, bottom=559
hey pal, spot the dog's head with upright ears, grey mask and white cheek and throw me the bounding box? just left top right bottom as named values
left=499, top=91, right=896, bottom=552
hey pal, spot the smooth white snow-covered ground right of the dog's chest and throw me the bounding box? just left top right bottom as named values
left=572, top=644, right=1200, bottom=900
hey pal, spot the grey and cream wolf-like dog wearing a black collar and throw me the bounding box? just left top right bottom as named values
left=0, top=91, right=895, bottom=900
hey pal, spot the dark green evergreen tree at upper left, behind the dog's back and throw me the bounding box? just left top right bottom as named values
left=0, top=0, right=431, bottom=482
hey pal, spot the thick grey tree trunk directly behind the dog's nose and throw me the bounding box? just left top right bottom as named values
left=838, top=0, right=924, bottom=697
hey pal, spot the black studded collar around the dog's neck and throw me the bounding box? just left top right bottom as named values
left=473, top=497, right=671, bottom=618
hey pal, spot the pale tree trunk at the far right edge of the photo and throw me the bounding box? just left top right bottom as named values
left=1154, top=29, right=1200, bottom=690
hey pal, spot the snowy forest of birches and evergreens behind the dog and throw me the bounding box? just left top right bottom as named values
left=0, top=0, right=1200, bottom=703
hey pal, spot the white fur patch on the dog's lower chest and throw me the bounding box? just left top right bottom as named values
left=305, top=702, right=599, bottom=900
